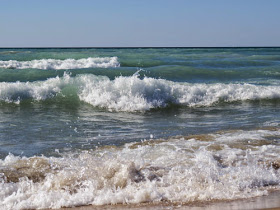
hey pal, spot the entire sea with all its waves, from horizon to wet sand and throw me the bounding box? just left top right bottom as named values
left=0, top=48, right=280, bottom=209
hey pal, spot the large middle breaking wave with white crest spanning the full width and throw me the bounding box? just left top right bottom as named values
left=0, top=74, right=280, bottom=112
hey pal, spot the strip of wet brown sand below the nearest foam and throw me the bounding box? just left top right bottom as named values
left=59, top=191, right=280, bottom=210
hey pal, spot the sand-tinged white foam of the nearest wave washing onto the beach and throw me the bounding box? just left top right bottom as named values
left=0, top=130, right=280, bottom=209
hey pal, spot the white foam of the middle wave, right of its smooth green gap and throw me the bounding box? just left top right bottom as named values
left=79, top=75, right=280, bottom=111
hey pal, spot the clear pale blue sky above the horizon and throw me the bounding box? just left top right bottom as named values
left=0, top=0, right=280, bottom=47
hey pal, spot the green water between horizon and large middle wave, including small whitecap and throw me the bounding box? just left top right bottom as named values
left=0, top=48, right=280, bottom=83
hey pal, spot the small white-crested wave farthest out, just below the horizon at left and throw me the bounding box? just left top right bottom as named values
left=0, top=57, right=120, bottom=69
